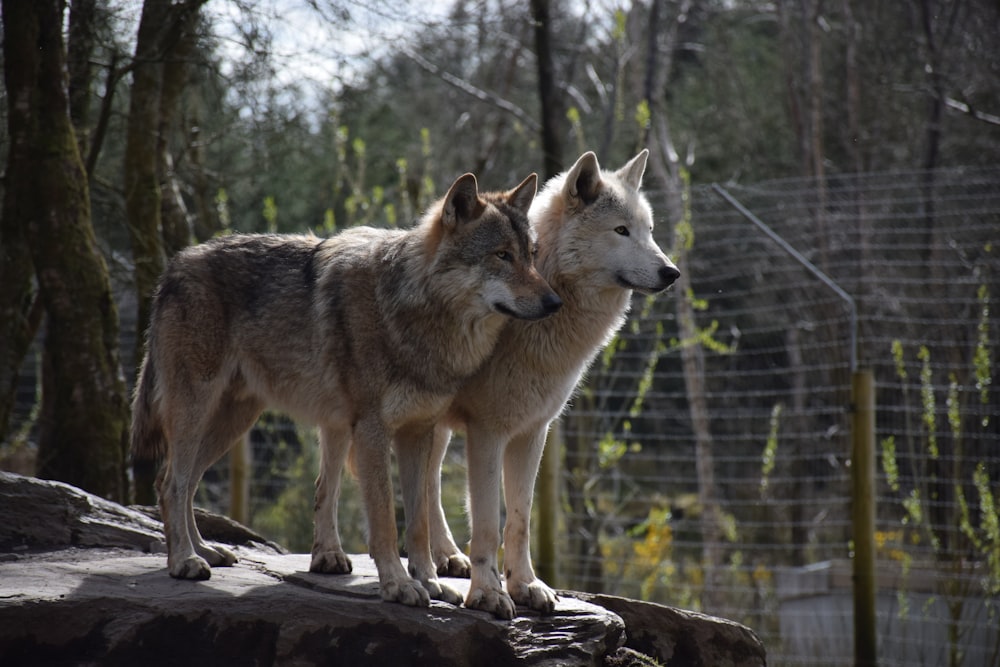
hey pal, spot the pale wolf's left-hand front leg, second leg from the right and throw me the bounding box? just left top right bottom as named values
left=465, top=423, right=514, bottom=619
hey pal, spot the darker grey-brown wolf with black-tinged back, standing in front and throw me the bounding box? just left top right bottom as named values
left=131, top=174, right=561, bottom=606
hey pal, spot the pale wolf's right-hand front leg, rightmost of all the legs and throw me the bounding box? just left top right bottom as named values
left=503, top=425, right=558, bottom=613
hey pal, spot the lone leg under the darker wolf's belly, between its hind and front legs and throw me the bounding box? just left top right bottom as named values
left=309, top=426, right=353, bottom=574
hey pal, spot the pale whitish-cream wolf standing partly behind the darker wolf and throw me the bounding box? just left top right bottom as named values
left=428, top=150, right=680, bottom=619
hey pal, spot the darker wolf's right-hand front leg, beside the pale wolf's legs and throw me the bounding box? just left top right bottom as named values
left=396, top=429, right=462, bottom=605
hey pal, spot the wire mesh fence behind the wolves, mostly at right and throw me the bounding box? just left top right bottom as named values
left=3, top=168, right=1000, bottom=667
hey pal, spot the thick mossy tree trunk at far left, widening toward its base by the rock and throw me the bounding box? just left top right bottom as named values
left=3, top=0, right=129, bottom=502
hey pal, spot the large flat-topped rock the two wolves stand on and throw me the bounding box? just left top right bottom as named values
left=0, top=473, right=765, bottom=667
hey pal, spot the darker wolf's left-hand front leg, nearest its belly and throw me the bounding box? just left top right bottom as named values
left=353, top=417, right=431, bottom=607
